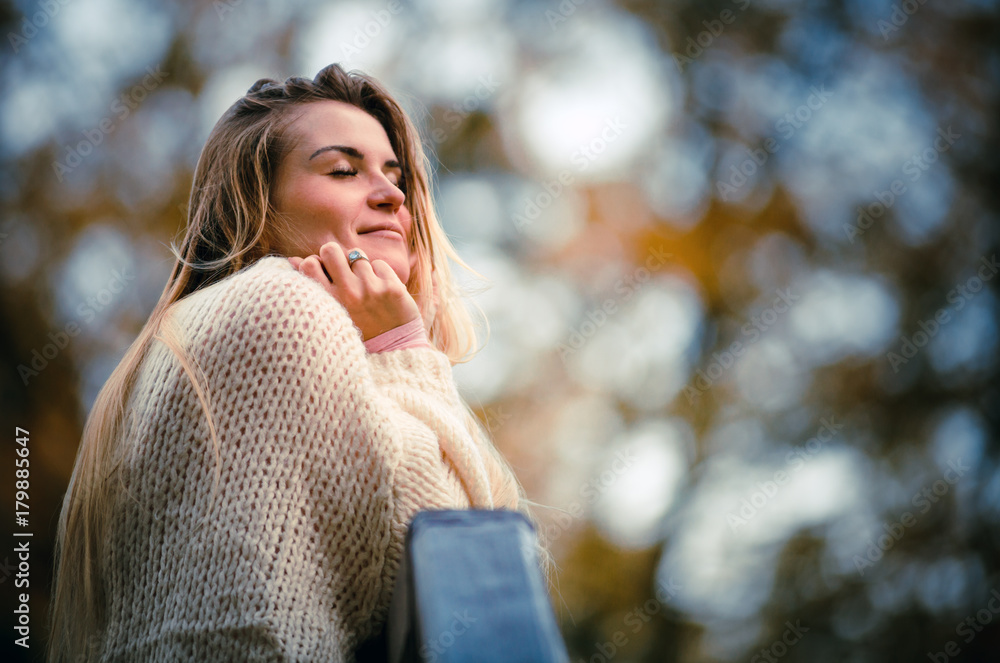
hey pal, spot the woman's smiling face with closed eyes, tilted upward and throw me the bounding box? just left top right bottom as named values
left=272, top=101, right=416, bottom=283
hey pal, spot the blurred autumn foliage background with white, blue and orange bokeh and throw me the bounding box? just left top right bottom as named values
left=0, top=0, right=1000, bottom=663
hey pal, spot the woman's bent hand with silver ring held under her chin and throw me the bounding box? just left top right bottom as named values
left=288, top=242, right=420, bottom=341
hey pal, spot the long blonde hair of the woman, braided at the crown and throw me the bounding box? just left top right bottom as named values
left=49, top=64, right=536, bottom=663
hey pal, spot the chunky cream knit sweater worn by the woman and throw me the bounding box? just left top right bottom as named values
left=101, top=257, right=517, bottom=663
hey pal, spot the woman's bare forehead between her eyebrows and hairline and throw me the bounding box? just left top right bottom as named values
left=289, top=100, right=394, bottom=158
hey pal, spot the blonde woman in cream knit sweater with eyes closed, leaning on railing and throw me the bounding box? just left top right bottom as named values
left=50, top=65, right=523, bottom=661
